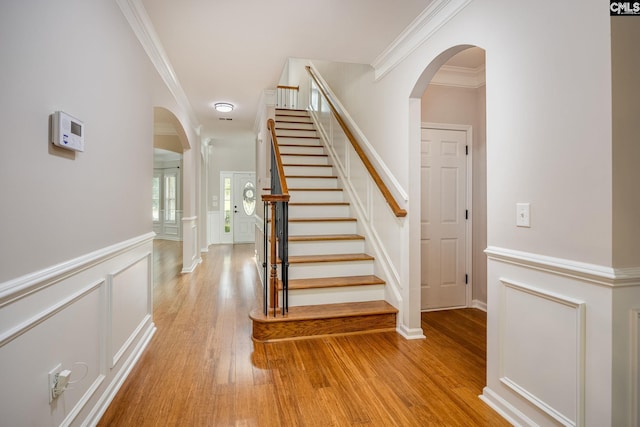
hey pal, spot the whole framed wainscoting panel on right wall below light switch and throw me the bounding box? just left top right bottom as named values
left=499, top=280, right=585, bottom=426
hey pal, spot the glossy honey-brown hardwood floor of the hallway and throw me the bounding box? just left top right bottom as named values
left=99, top=242, right=509, bottom=426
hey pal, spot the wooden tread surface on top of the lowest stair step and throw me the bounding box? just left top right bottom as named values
left=251, top=301, right=398, bottom=323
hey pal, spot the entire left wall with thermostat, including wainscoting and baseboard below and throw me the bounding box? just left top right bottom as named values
left=0, top=0, right=155, bottom=425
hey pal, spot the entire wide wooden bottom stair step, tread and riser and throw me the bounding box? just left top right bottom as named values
left=249, top=301, right=398, bottom=342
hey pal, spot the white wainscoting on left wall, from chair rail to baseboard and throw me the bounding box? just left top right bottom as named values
left=0, top=233, right=155, bottom=426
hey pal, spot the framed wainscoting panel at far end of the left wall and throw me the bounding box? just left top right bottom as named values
left=109, top=253, right=153, bottom=368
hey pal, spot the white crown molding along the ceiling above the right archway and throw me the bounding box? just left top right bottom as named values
left=371, top=0, right=472, bottom=80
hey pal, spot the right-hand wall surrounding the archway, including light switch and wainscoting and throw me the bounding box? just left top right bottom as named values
left=298, top=0, right=640, bottom=426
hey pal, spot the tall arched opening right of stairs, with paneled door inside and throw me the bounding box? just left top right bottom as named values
left=412, top=45, right=487, bottom=311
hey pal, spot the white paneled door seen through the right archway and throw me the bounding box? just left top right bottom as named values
left=420, top=128, right=470, bottom=310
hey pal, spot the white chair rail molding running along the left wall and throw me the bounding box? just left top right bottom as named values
left=0, top=232, right=155, bottom=308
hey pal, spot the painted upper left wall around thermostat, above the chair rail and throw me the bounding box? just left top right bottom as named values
left=0, top=0, right=153, bottom=281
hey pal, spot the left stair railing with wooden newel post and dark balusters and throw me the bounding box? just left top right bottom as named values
left=262, top=119, right=290, bottom=317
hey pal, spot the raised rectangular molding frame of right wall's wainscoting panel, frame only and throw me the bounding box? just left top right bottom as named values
left=498, top=279, right=586, bottom=426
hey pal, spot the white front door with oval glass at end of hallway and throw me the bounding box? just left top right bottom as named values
left=233, top=173, right=257, bottom=243
